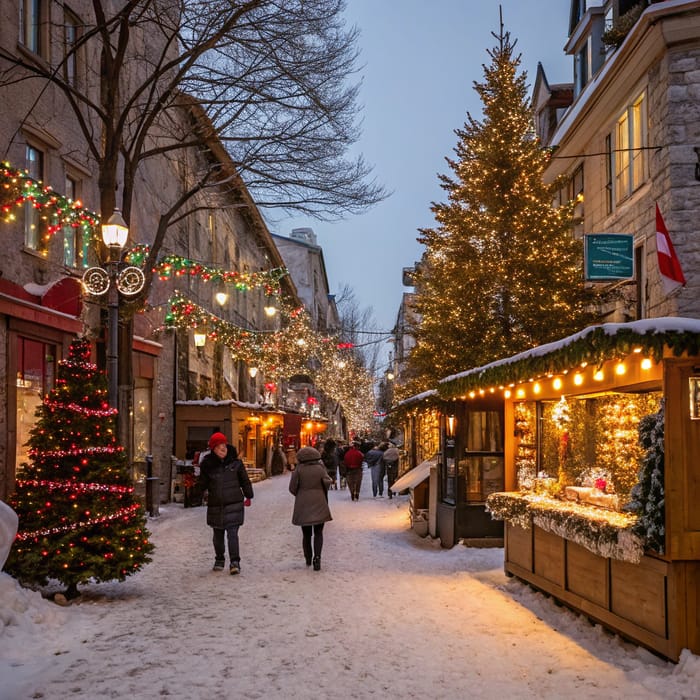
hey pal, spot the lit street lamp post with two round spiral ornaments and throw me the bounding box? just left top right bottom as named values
left=83, top=209, right=146, bottom=408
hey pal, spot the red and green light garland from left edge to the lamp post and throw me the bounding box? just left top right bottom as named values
left=0, top=162, right=100, bottom=239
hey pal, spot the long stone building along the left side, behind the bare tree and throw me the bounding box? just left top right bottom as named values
left=0, top=0, right=298, bottom=498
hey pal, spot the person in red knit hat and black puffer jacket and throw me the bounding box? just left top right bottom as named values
left=199, top=433, right=253, bottom=574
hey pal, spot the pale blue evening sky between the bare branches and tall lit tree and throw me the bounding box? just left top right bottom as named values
left=270, top=0, right=573, bottom=344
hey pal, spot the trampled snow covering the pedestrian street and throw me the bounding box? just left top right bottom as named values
left=0, top=472, right=700, bottom=700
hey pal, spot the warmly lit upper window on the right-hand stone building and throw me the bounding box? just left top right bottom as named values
left=606, top=94, right=647, bottom=205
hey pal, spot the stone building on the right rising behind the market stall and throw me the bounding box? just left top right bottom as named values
left=534, top=0, right=700, bottom=321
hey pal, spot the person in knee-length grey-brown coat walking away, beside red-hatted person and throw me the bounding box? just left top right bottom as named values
left=289, top=447, right=333, bottom=571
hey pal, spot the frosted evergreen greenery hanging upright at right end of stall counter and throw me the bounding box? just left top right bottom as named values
left=625, top=402, right=666, bottom=554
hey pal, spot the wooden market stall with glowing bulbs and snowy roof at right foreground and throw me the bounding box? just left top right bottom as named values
left=439, top=318, right=700, bottom=661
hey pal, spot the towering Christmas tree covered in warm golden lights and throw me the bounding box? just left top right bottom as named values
left=409, top=20, right=593, bottom=391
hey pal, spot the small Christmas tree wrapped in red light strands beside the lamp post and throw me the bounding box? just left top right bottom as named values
left=5, top=339, right=153, bottom=598
